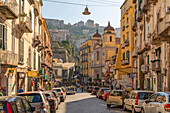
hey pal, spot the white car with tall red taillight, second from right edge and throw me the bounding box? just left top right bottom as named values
left=123, top=90, right=153, bottom=113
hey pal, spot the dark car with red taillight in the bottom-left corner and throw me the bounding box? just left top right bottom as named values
left=0, top=96, right=35, bottom=113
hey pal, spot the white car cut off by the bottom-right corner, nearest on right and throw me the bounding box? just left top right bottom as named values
left=141, top=92, right=170, bottom=113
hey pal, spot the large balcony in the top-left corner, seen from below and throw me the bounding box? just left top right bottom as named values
left=0, top=0, right=18, bottom=20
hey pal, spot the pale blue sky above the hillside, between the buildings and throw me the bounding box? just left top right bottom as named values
left=42, top=0, right=125, bottom=28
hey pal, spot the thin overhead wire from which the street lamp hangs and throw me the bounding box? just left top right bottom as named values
left=44, top=0, right=118, bottom=7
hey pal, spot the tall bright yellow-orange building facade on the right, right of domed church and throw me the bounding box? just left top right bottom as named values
left=114, top=0, right=134, bottom=87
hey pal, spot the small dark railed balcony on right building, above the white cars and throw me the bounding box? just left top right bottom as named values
left=151, top=59, right=161, bottom=72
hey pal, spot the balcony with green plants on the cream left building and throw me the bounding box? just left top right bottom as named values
left=18, top=16, right=32, bottom=33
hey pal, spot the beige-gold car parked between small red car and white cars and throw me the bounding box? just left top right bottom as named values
left=106, top=90, right=128, bottom=107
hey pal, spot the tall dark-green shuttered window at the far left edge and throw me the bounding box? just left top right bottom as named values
left=0, top=24, right=7, bottom=50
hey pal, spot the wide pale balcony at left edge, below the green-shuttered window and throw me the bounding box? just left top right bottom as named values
left=0, top=50, right=18, bottom=66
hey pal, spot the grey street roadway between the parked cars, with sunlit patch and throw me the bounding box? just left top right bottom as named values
left=57, top=89, right=130, bottom=113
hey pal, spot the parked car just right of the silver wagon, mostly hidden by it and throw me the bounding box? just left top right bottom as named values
left=43, top=91, right=58, bottom=113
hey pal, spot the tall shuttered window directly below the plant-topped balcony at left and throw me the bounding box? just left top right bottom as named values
left=19, top=37, right=24, bottom=62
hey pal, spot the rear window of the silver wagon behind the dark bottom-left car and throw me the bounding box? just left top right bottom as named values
left=18, top=93, right=42, bottom=103
